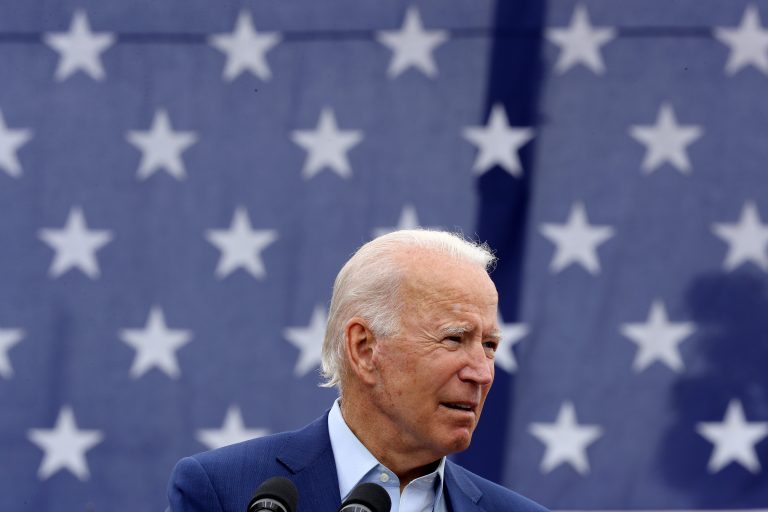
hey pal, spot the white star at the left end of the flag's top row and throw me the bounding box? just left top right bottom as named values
left=43, top=10, right=115, bottom=82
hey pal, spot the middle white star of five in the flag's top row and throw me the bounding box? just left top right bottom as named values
left=376, top=7, right=448, bottom=79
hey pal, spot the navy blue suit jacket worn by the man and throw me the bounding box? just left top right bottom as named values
left=168, top=414, right=546, bottom=512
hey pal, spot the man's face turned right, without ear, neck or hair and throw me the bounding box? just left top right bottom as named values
left=372, top=251, right=499, bottom=460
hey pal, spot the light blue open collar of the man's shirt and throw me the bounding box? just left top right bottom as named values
left=328, top=398, right=445, bottom=503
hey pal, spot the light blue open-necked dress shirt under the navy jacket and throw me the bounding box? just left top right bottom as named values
left=328, top=400, right=447, bottom=512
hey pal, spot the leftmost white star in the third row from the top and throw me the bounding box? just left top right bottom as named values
left=38, top=206, right=112, bottom=279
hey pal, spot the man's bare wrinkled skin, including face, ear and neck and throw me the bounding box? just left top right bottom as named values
left=342, top=249, right=499, bottom=485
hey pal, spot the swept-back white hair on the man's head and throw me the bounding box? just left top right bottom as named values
left=321, top=229, right=496, bottom=391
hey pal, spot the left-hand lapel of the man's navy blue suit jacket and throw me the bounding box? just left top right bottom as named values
left=277, top=413, right=341, bottom=512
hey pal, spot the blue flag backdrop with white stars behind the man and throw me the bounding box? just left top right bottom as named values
left=0, top=0, right=768, bottom=512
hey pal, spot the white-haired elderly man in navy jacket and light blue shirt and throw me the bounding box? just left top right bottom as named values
left=168, top=230, right=545, bottom=512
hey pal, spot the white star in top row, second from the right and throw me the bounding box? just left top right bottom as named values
left=547, top=4, right=616, bottom=74
